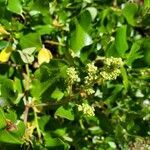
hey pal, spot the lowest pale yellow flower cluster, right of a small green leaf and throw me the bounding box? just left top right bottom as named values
left=78, top=103, right=95, bottom=117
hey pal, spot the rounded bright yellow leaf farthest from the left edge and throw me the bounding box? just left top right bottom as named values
left=38, top=48, right=53, bottom=65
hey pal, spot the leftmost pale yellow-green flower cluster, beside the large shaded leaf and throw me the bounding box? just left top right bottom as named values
left=67, top=67, right=80, bottom=84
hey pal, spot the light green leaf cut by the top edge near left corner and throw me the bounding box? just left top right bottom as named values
left=7, top=0, right=22, bottom=15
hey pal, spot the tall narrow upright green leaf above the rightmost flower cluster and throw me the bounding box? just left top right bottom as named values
left=115, top=25, right=128, bottom=56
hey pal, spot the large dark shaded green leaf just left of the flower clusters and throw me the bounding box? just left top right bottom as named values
left=31, top=60, right=66, bottom=99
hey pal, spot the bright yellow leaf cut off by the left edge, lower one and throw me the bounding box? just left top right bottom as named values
left=0, top=46, right=13, bottom=63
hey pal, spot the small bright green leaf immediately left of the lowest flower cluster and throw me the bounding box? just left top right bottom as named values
left=55, top=106, right=74, bottom=120
